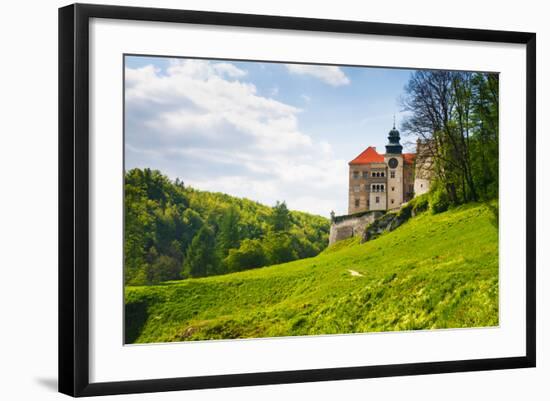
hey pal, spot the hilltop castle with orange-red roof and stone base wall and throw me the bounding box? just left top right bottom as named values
left=329, top=122, right=432, bottom=244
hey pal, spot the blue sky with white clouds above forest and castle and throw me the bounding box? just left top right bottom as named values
left=125, top=56, right=412, bottom=216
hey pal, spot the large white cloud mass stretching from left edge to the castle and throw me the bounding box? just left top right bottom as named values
left=125, top=60, right=347, bottom=216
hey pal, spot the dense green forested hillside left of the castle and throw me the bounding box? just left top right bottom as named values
left=124, top=169, right=330, bottom=285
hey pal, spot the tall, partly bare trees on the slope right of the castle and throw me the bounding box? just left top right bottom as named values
left=402, top=70, right=499, bottom=209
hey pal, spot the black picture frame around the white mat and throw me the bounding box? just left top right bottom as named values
left=59, top=4, right=536, bottom=396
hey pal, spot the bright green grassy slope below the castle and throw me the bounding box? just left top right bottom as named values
left=125, top=204, right=498, bottom=343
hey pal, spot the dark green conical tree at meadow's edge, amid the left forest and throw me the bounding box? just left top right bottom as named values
left=182, top=225, right=218, bottom=277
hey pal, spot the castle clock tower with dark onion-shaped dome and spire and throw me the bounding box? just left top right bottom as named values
left=384, top=118, right=404, bottom=210
